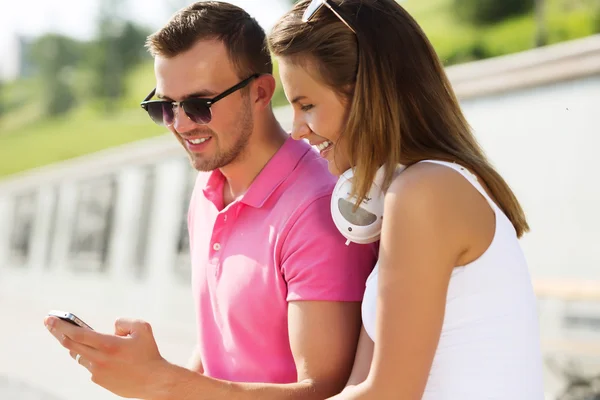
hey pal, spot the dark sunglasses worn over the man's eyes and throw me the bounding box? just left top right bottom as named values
left=140, top=74, right=260, bottom=126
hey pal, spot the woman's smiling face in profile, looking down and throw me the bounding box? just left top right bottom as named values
left=278, top=58, right=350, bottom=176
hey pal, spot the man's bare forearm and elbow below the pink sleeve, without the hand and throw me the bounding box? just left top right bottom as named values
left=154, top=301, right=360, bottom=400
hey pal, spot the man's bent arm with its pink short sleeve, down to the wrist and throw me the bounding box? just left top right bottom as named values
left=156, top=196, right=375, bottom=400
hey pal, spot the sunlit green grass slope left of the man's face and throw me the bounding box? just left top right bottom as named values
left=0, top=64, right=166, bottom=176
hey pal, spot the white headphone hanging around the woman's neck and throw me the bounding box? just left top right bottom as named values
left=331, top=165, right=404, bottom=245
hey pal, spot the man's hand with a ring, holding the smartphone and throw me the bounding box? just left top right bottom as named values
left=44, top=317, right=174, bottom=399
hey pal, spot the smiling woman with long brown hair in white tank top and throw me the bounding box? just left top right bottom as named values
left=269, top=0, right=544, bottom=400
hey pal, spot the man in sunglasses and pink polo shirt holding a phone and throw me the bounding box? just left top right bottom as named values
left=46, top=2, right=376, bottom=400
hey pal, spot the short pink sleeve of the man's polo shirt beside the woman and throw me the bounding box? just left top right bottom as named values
left=281, top=196, right=377, bottom=301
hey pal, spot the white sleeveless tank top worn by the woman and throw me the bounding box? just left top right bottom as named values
left=362, top=160, right=544, bottom=400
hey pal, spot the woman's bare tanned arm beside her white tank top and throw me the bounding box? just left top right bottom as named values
left=333, top=164, right=478, bottom=400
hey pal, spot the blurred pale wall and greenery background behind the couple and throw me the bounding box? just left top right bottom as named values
left=0, top=0, right=600, bottom=400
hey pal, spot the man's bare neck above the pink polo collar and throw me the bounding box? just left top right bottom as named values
left=220, top=112, right=288, bottom=206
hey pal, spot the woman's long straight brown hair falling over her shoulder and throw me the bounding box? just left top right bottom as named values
left=268, top=0, right=529, bottom=237
